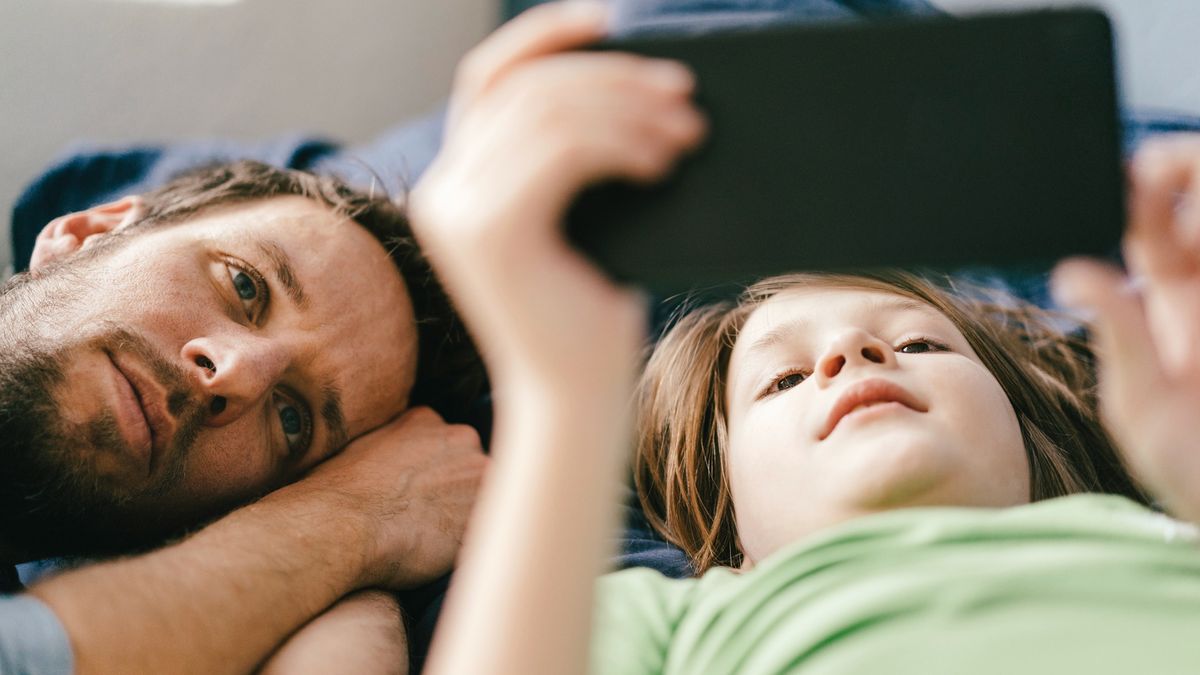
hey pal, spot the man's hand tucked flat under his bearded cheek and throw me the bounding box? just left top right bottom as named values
left=295, top=407, right=487, bottom=589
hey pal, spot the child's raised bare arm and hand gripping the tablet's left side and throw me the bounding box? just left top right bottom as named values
left=410, top=1, right=704, bottom=674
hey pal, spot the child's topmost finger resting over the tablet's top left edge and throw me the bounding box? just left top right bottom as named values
left=456, top=0, right=608, bottom=98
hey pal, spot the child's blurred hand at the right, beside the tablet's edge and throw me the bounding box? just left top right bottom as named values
left=1054, top=136, right=1200, bottom=521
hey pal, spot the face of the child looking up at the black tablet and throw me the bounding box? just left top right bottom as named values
left=726, top=287, right=1030, bottom=563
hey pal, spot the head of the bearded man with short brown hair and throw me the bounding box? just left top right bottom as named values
left=0, top=162, right=480, bottom=557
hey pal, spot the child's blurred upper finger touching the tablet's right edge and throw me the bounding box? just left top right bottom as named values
left=1126, top=137, right=1200, bottom=277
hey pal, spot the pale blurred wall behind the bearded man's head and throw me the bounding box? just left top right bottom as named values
left=0, top=0, right=499, bottom=275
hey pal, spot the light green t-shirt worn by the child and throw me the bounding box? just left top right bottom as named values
left=592, top=495, right=1200, bottom=675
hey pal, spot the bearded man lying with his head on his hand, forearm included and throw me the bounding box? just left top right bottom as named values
left=0, top=162, right=484, bottom=671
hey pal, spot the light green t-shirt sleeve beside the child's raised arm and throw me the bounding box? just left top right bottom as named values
left=590, top=569, right=696, bottom=675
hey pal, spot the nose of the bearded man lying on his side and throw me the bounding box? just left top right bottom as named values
left=182, top=335, right=290, bottom=426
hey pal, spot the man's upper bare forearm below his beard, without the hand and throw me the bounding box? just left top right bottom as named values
left=31, top=485, right=372, bottom=674
